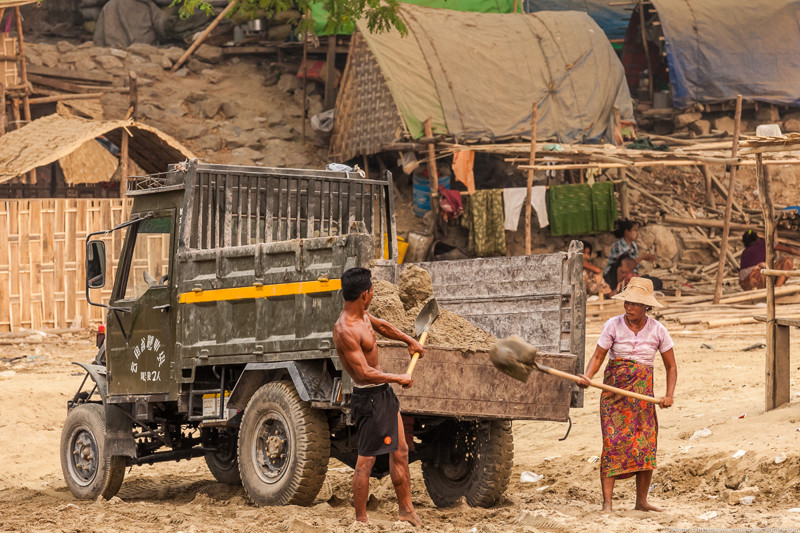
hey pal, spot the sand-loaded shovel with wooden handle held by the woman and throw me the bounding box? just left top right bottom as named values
left=489, top=335, right=659, bottom=403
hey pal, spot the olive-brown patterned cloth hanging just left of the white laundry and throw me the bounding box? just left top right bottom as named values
left=461, top=189, right=506, bottom=257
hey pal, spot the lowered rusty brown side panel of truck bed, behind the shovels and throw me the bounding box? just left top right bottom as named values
left=380, top=343, right=575, bottom=422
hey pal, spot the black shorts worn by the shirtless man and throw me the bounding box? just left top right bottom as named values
left=350, top=383, right=400, bottom=457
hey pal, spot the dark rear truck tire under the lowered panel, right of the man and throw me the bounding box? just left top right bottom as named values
left=422, top=420, right=514, bottom=507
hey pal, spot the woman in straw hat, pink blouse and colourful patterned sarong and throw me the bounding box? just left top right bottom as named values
left=579, top=277, right=678, bottom=511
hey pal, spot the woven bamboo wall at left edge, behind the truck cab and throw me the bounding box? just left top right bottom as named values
left=0, top=199, right=131, bottom=331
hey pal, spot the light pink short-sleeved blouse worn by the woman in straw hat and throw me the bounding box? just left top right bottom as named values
left=597, top=315, right=675, bottom=366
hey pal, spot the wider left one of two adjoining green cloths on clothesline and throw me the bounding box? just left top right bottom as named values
left=548, top=183, right=594, bottom=236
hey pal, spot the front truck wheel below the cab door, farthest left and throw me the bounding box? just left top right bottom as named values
left=61, top=403, right=125, bottom=500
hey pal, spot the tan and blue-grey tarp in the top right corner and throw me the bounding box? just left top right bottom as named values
left=652, top=0, right=800, bottom=108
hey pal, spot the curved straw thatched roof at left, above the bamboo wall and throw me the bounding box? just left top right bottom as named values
left=0, top=114, right=195, bottom=183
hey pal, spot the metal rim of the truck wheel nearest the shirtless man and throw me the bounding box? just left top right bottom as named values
left=252, top=410, right=291, bottom=484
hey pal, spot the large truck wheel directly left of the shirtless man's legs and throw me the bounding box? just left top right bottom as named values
left=239, top=381, right=331, bottom=505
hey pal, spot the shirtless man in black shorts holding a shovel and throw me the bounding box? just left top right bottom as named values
left=333, top=268, right=424, bottom=526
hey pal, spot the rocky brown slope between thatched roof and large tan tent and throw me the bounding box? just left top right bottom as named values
left=25, top=41, right=326, bottom=168
